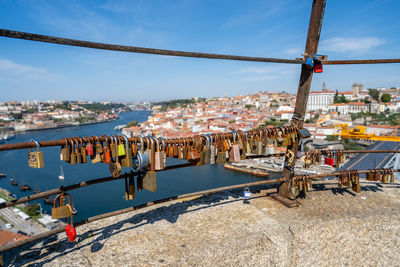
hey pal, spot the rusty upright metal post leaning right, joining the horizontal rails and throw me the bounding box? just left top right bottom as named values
left=278, top=0, right=326, bottom=206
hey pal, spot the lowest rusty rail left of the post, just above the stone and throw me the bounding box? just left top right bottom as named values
left=0, top=179, right=282, bottom=253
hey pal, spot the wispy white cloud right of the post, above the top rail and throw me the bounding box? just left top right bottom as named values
left=320, top=37, right=385, bottom=53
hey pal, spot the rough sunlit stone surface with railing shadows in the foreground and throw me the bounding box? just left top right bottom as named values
left=4, top=179, right=400, bottom=266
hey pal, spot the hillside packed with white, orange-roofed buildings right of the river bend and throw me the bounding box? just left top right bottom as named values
left=123, top=83, right=400, bottom=140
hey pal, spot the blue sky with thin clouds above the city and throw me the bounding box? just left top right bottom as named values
left=0, top=0, right=400, bottom=101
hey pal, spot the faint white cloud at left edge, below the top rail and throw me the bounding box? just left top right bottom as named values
left=0, top=58, right=53, bottom=80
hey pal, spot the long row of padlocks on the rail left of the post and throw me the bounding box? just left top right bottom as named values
left=28, top=126, right=304, bottom=177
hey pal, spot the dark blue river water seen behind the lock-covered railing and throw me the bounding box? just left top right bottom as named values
left=0, top=111, right=260, bottom=222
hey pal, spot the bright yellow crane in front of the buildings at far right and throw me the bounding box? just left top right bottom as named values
left=333, top=123, right=400, bottom=142
